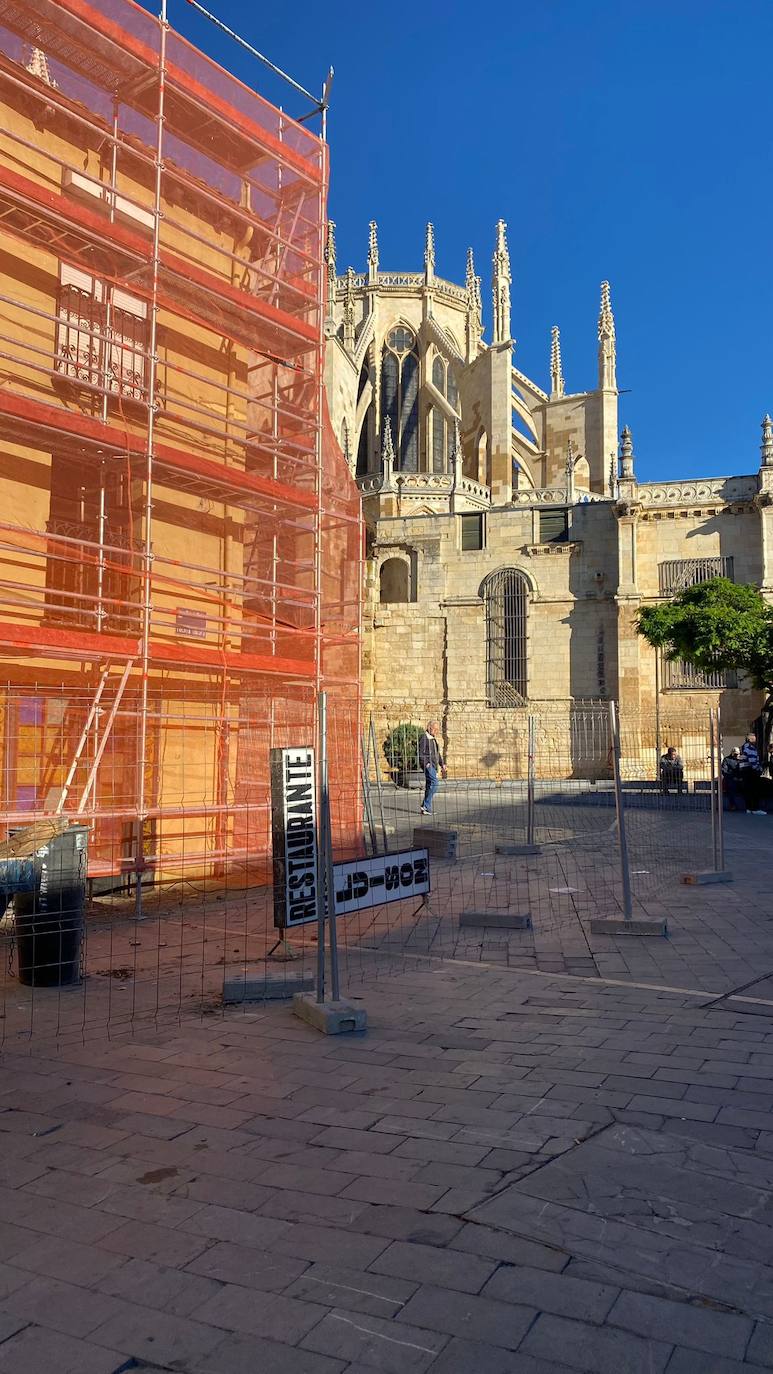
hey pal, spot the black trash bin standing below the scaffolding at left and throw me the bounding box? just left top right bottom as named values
left=14, top=826, right=88, bottom=988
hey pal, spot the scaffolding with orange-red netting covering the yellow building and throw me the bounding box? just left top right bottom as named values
left=0, top=0, right=362, bottom=911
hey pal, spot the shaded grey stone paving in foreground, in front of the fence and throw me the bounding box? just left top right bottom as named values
left=0, top=965, right=773, bottom=1374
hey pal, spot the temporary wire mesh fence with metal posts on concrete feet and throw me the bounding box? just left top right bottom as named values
left=0, top=694, right=752, bottom=1043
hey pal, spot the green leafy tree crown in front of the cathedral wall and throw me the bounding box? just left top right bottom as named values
left=638, top=577, right=773, bottom=691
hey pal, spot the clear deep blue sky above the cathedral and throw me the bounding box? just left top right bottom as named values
left=154, top=0, right=773, bottom=480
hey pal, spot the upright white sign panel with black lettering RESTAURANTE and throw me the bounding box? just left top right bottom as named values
left=270, top=749, right=317, bottom=930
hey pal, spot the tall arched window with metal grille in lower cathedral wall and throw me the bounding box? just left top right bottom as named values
left=483, top=567, right=529, bottom=708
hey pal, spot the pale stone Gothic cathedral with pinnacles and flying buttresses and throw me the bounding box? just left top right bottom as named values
left=325, top=221, right=773, bottom=772
